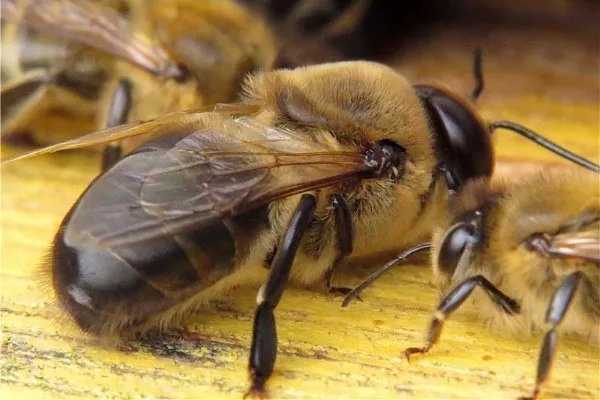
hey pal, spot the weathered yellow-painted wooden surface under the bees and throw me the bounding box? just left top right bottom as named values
left=0, top=10, right=600, bottom=399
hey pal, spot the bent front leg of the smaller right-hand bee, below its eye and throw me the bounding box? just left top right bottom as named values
left=404, top=275, right=520, bottom=360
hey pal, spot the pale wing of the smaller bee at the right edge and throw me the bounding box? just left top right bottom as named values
left=549, top=221, right=600, bottom=264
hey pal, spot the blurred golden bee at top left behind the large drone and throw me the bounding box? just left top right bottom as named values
left=2, top=0, right=275, bottom=168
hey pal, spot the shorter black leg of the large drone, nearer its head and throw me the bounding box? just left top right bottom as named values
left=325, top=194, right=354, bottom=300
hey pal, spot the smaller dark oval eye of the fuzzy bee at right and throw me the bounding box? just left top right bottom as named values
left=438, top=222, right=477, bottom=278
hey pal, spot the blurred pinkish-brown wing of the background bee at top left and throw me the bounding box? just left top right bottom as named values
left=1, top=0, right=180, bottom=77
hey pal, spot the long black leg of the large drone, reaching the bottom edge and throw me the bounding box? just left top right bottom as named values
left=244, top=194, right=316, bottom=397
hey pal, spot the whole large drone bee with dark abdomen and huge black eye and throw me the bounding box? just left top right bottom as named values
left=5, top=57, right=600, bottom=394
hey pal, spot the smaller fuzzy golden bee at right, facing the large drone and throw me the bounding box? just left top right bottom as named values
left=344, top=169, right=600, bottom=398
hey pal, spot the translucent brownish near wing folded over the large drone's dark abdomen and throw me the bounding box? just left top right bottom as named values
left=65, top=113, right=368, bottom=248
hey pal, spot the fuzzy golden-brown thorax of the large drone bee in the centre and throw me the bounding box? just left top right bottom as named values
left=245, top=62, right=447, bottom=281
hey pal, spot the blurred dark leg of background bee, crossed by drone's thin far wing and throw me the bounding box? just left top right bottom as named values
left=102, top=78, right=131, bottom=171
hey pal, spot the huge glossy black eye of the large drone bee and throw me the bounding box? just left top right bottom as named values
left=415, top=85, right=494, bottom=191
